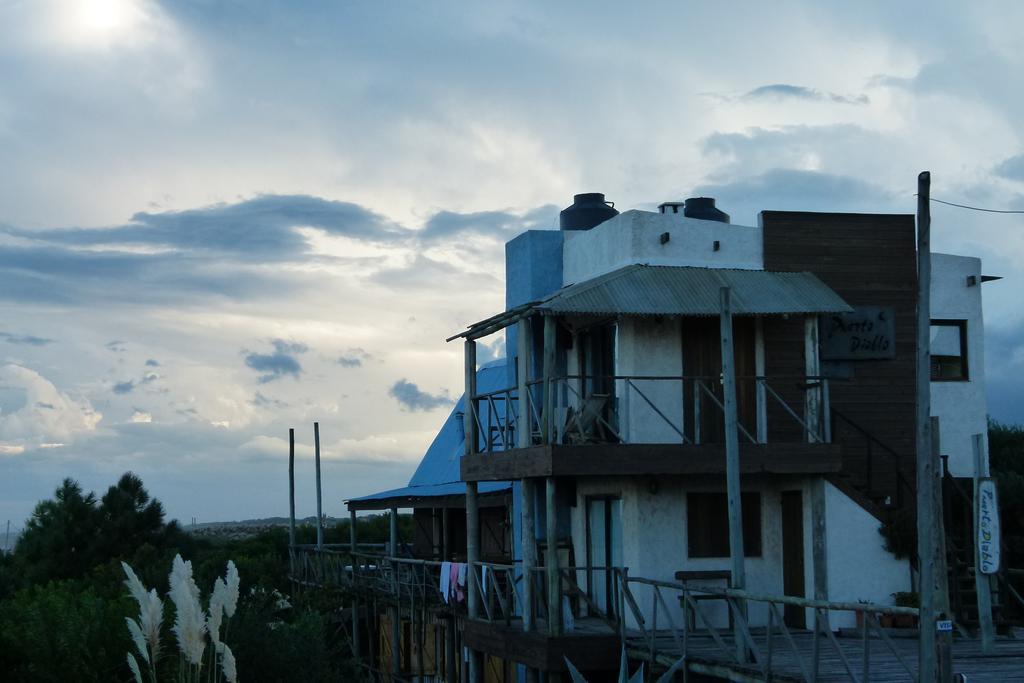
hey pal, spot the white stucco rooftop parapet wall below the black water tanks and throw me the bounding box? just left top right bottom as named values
left=562, top=211, right=764, bottom=285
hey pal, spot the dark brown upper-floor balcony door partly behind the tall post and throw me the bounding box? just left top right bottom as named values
left=683, top=316, right=757, bottom=443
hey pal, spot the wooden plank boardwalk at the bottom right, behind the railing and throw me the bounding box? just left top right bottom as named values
left=627, top=630, right=1024, bottom=683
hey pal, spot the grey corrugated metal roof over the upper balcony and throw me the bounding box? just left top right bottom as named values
left=536, top=264, right=852, bottom=315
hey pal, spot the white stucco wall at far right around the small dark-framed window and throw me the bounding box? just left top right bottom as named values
left=931, top=254, right=988, bottom=476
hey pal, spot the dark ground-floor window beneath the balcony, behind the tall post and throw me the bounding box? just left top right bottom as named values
left=686, top=492, right=761, bottom=557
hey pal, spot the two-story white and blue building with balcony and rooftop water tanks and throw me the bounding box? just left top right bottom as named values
left=309, top=194, right=999, bottom=681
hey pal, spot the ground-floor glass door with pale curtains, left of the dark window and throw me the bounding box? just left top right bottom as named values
left=587, top=496, right=623, bottom=614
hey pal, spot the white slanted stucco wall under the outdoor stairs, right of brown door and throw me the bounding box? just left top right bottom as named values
left=823, top=481, right=910, bottom=629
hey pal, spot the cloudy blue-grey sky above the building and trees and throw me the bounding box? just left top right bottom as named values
left=0, top=0, right=1024, bottom=524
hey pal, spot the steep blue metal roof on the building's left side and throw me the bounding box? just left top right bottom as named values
left=349, top=358, right=512, bottom=503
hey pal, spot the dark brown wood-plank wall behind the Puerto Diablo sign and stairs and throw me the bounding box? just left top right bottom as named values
left=761, top=211, right=918, bottom=496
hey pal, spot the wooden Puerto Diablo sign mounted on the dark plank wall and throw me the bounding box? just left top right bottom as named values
left=821, top=306, right=896, bottom=360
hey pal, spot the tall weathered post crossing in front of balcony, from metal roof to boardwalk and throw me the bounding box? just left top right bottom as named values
left=719, top=287, right=746, bottom=661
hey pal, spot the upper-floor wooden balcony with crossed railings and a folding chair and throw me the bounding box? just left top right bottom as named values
left=461, top=376, right=842, bottom=481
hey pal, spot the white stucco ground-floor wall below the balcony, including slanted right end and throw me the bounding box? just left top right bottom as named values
left=571, top=476, right=910, bottom=629
